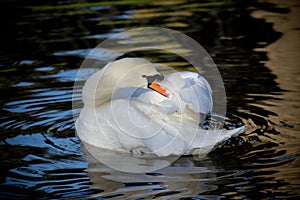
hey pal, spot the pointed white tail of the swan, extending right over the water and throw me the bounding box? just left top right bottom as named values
left=186, top=126, right=246, bottom=155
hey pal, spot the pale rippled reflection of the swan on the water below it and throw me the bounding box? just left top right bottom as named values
left=87, top=157, right=220, bottom=199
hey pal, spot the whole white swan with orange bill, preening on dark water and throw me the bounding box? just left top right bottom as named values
left=76, top=58, right=245, bottom=156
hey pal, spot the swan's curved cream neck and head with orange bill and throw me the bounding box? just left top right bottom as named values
left=82, top=58, right=167, bottom=107
